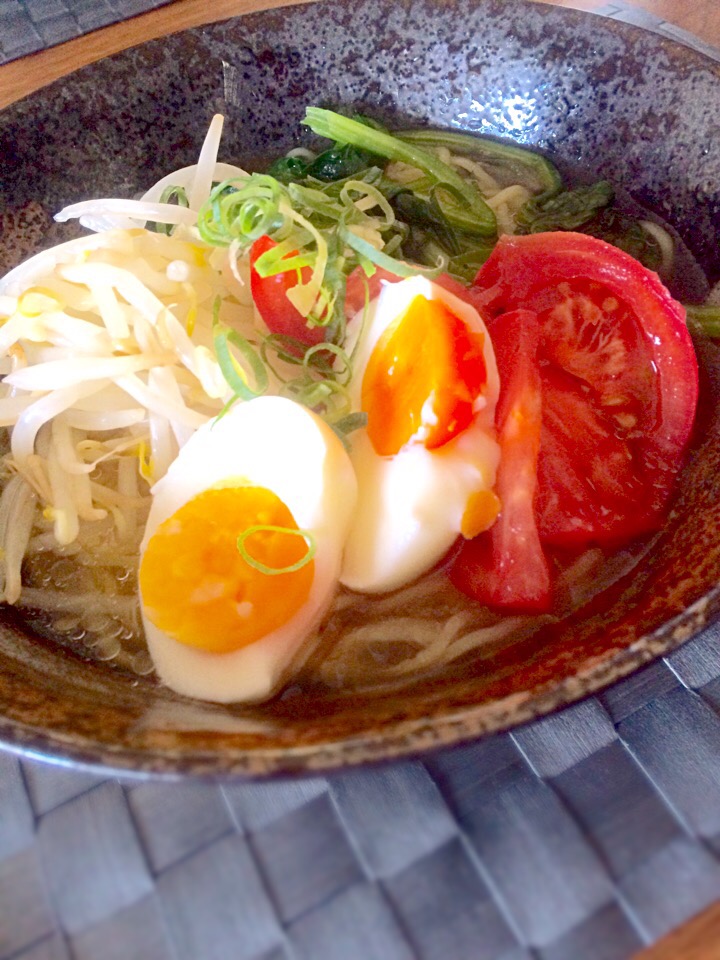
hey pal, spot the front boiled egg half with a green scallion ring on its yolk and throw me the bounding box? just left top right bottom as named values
left=139, top=397, right=356, bottom=703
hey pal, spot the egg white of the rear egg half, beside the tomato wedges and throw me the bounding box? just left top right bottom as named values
left=340, top=277, right=500, bottom=593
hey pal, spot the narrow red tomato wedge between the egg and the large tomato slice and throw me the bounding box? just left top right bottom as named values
left=450, top=310, right=551, bottom=613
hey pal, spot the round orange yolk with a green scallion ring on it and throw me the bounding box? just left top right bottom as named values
left=140, top=486, right=315, bottom=653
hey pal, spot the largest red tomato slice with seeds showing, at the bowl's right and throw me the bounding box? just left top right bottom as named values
left=475, top=232, right=698, bottom=546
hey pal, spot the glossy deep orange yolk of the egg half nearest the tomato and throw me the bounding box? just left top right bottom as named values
left=361, top=295, right=487, bottom=457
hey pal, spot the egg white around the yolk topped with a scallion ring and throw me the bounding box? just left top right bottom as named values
left=141, top=397, right=356, bottom=703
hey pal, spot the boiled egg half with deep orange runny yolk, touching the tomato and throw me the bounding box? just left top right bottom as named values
left=341, top=277, right=500, bottom=592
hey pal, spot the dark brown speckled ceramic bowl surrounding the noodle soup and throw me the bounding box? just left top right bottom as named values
left=0, top=0, right=720, bottom=776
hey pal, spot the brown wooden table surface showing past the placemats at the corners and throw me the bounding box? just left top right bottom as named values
left=0, top=0, right=720, bottom=960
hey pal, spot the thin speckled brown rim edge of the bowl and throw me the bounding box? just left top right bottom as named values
left=0, top=5, right=720, bottom=779
